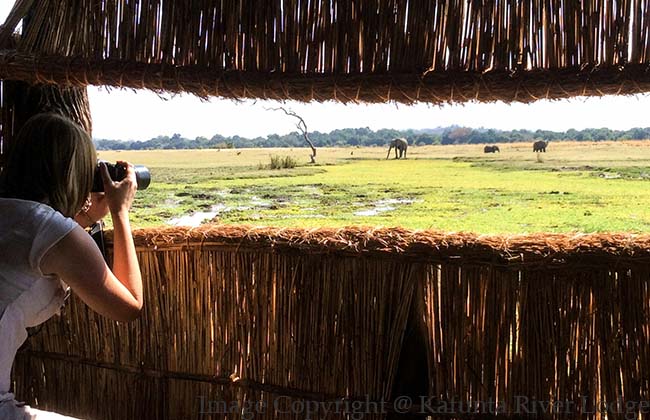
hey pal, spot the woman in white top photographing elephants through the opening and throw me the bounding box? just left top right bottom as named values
left=0, top=114, right=142, bottom=420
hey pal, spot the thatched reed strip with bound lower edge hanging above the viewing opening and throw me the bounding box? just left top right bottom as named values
left=0, top=0, right=650, bottom=103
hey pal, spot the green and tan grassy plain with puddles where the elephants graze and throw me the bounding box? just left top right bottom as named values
left=99, top=141, right=650, bottom=233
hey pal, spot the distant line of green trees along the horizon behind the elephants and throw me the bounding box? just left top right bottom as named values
left=94, top=126, right=650, bottom=150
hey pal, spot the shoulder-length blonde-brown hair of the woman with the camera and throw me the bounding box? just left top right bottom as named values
left=0, top=113, right=97, bottom=217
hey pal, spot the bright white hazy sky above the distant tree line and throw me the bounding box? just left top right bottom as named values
left=0, top=0, right=650, bottom=140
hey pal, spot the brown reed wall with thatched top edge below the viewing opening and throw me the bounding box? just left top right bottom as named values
left=14, top=226, right=650, bottom=419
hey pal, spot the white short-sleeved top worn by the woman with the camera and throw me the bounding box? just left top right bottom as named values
left=0, top=198, right=79, bottom=405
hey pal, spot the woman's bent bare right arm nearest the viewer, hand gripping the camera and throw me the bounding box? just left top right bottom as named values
left=41, top=162, right=143, bottom=321
